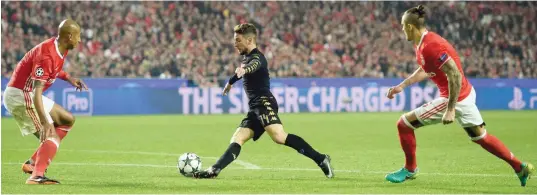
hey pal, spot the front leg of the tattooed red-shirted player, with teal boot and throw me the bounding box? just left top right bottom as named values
left=386, top=113, right=422, bottom=183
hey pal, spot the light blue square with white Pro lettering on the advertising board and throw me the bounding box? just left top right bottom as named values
left=63, top=88, right=93, bottom=116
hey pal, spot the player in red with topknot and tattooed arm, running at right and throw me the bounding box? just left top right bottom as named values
left=386, top=5, right=535, bottom=186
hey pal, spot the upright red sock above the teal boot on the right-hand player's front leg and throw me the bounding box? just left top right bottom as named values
left=397, top=116, right=417, bottom=172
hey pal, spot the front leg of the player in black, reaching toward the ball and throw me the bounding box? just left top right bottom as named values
left=193, top=127, right=254, bottom=179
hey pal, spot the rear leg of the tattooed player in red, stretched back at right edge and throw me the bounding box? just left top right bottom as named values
left=464, top=125, right=535, bottom=186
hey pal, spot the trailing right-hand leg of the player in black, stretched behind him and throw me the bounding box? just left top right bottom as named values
left=265, top=124, right=334, bottom=178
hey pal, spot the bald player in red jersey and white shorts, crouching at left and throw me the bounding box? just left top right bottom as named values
left=4, top=20, right=87, bottom=184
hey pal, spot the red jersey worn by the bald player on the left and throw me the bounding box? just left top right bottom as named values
left=8, top=37, right=67, bottom=92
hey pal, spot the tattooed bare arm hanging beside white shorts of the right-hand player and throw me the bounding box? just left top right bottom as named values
left=441, top=59, right=462, bottom=124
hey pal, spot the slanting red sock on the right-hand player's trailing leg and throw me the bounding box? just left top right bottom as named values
left=473, top=132, right=522, bottom=173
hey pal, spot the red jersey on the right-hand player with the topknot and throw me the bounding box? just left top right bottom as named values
left=414, top=31, right=472, bottom=101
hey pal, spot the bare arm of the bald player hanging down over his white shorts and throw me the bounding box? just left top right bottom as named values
left=33, top=80, right=56, bottom=142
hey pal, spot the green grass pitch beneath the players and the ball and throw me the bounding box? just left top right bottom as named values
left=1, top=111, right=537, bottom=194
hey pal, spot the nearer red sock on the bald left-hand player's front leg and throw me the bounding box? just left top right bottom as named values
left=32, top=140, right=60, bottom=177
